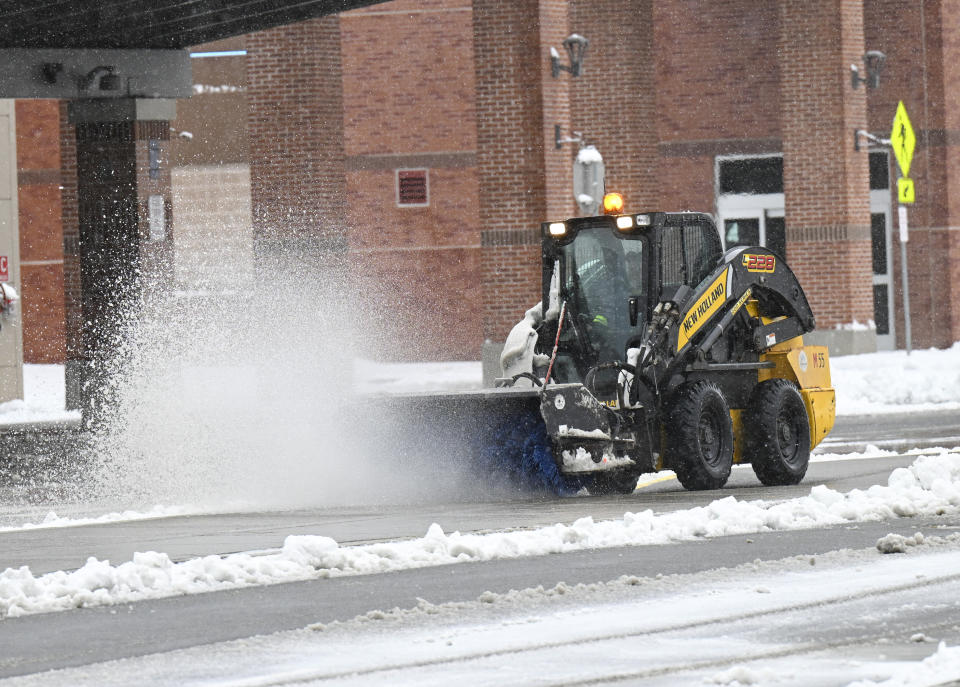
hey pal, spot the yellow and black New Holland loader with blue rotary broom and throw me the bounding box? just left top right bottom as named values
left=366, top=194, right=835, bottom=494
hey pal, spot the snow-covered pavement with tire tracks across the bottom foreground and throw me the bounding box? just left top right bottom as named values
left=4, top=536, right=960, bottom=687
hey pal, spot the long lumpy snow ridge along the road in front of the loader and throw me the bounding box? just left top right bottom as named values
left=0, top=450, right=960, bottom=617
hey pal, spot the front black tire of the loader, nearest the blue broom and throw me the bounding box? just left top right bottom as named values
left=666, top=381, right=733, bottom=491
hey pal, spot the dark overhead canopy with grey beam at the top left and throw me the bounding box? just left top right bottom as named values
left=0, top=0, right=383, bottom=100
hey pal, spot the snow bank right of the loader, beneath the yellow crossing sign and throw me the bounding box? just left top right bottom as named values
left=830, top=341, right=960, bottom=415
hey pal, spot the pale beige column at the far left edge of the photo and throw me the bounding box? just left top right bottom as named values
left=0, top=100, right=23, bottom=403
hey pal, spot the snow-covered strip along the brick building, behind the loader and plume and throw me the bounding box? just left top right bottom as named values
left=7, top=342, right=960, bottom=425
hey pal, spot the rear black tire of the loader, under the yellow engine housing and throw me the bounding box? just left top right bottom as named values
left=743, top=379, right=810, bottom=486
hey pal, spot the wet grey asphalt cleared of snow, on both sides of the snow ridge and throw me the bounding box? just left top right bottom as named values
left=0, top=413, right=960, bottom=676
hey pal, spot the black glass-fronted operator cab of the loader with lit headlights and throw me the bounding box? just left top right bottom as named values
left=541, top=212, right=722, bottom=389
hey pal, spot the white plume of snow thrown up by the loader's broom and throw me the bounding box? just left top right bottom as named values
left=82, top=251, right=468, bottom=510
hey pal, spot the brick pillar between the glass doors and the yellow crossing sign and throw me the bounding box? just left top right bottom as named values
left=777, top=0, right=876, bottom=350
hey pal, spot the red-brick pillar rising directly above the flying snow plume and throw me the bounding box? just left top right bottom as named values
left=246, top=16, right=347, bottom=268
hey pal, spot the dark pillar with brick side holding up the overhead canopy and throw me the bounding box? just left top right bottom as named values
left=63, top=100, right=175, bottom=416
